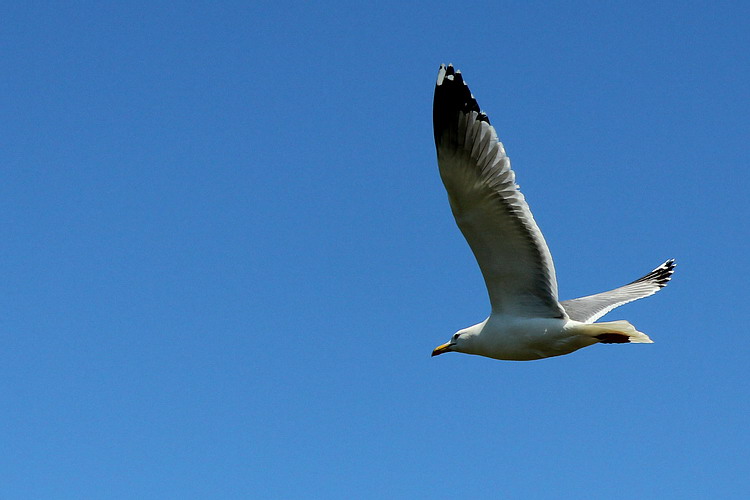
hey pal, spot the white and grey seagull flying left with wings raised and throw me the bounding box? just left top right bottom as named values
left=432, top=64, right=675, bottom=361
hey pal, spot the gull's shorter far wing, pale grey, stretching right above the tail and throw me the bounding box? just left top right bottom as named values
left=561, top=259, right=675, bottom=323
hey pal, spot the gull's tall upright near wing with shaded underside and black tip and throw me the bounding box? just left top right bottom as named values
left=433, top=65, right=565, bottom=318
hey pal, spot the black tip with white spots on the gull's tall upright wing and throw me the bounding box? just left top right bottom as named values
left=432, top=63, right=490, bottom=146
